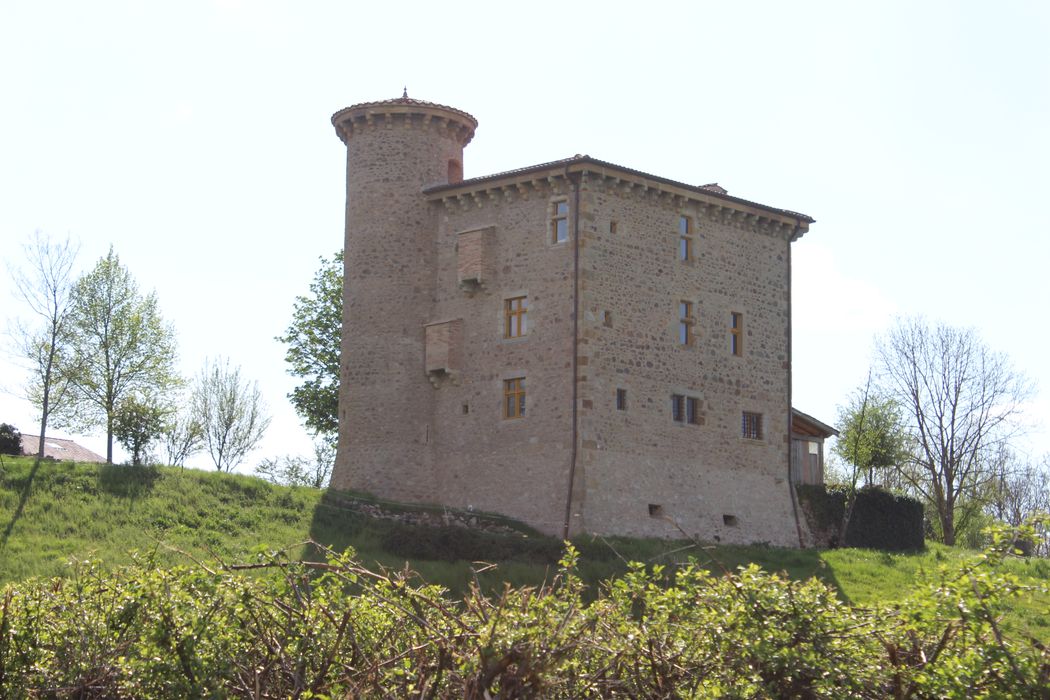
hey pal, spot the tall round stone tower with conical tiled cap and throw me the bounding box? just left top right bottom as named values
left=332, top=93, right=478, bottom=501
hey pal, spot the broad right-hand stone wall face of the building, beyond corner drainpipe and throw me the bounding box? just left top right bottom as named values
left=573, top=176, right=798, bottom=546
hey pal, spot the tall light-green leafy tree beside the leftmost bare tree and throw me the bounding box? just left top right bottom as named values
left=61, top=248, right=179, bottom=463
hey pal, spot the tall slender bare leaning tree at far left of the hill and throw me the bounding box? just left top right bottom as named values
left=11, top=231, right=80, bottom=459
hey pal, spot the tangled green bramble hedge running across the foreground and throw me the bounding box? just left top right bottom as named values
left=0, top=520, right=1050, bottom=698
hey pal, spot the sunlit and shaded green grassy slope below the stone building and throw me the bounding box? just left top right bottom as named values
left=0, top=458, right=1050, bottom=639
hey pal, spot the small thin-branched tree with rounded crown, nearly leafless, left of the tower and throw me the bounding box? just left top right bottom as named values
left=192, top=360, right=270, bottom=471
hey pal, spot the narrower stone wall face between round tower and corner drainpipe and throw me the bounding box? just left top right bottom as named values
left=422, top=179, right=572, bottom=534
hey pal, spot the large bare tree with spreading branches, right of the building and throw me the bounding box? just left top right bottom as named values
left=878, top=318, right=1030, bottom=545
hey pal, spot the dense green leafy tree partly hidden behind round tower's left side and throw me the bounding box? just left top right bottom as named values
left=277, top=251, right=343, bottom=434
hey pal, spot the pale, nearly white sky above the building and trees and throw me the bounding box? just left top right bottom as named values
left=0, top=0, right=1050, bottom=471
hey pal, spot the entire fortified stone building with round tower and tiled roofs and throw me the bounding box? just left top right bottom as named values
left=332, top=96, right=814, bottom=546
